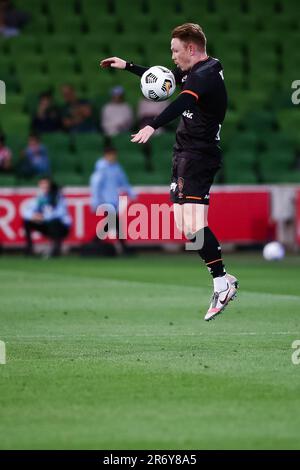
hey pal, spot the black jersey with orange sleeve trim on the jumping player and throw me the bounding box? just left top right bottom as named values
left=174, top=57, right=227, bottom=156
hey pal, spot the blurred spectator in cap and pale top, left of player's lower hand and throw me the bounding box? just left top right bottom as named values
left=100, top=86, right=133, bottom=136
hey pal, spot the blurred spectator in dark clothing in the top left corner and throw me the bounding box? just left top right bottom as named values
left=0, top=0, right=30, bottom=37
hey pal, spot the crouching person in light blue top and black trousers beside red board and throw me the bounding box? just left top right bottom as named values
left=23, top=177, right=71, bottom=257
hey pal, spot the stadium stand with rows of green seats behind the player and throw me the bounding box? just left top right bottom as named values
left=0, top=0, right=300, bottom=185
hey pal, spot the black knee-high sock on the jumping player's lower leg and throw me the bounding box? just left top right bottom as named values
left=195, top=227, right=226, bottom=278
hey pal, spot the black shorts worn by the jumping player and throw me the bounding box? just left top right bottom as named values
left=170, top=153, right=221, bottom=204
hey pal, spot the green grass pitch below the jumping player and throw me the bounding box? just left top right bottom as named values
left=0, top=254, right=300, bottom=449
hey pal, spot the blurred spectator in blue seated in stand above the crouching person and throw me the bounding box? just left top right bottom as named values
left=18, top=134, right=50, bottom=178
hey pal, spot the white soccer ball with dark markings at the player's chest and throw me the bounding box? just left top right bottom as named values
left=141, top=65, right=176, bottom=101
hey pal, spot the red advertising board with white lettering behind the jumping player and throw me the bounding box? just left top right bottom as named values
left=0, top=186, right=272, bottom=246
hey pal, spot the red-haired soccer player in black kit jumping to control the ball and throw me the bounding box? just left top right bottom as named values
left=100, top=23, right=238, bottom=320
